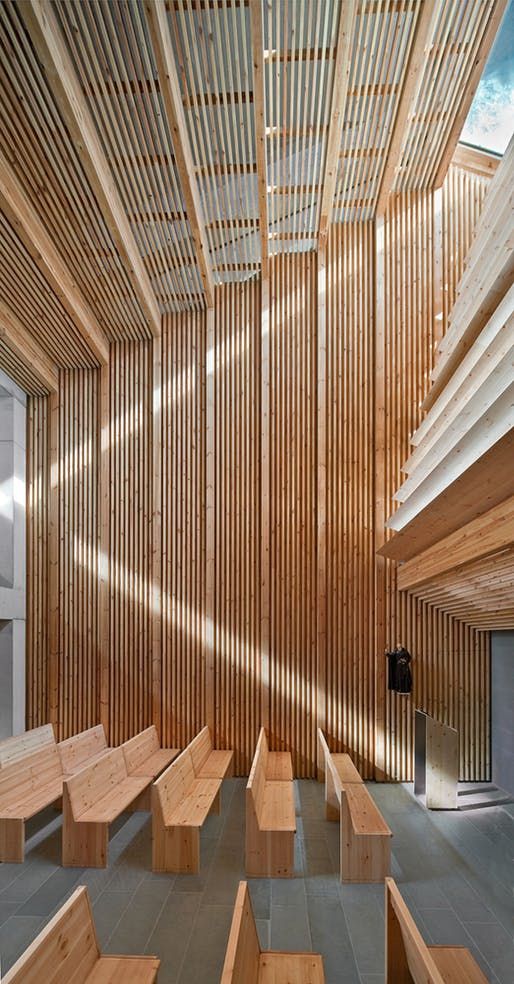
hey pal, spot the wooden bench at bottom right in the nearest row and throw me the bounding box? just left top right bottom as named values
left=385, top=878, right=487, bottom=984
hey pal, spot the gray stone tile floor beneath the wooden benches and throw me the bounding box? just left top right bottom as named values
left=0, top=779, right=514, bottom=984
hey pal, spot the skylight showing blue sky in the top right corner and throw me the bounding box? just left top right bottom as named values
left=460, top=0, right=514, bottom=154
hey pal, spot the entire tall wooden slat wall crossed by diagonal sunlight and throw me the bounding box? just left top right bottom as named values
left=28, top=161, right=489, bottom=779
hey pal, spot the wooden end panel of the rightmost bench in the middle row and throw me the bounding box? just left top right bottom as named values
left=340, top=809, right=391, bottom=882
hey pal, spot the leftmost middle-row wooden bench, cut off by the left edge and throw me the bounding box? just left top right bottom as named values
left=0, top=742, right=63, bottom=862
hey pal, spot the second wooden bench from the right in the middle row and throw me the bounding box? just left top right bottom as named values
left=246, top=728, right=296, bottom=878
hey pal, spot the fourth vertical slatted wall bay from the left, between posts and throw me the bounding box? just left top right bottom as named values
left=160, top=313, right=206, bottom=747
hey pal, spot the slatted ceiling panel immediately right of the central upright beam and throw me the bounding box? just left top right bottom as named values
left=263, top=0, right=339, bottom=246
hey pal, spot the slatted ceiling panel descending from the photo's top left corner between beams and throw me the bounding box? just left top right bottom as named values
left=0, top=3, right=148, bottom=344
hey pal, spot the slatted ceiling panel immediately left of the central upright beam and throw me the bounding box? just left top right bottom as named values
left=169, top=0, right=260, bottom=283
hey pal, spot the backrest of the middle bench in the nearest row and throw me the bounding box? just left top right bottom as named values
left=221, top=882, right=261, bottom=984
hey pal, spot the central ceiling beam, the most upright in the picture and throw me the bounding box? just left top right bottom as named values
left=250, top=0, right=269, bottom=278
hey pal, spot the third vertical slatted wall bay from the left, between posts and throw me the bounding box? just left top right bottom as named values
left=101, top=342, right=153, bottom=744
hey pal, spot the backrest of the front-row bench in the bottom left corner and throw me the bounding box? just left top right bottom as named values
left=2, top=885, right=100, bottom=984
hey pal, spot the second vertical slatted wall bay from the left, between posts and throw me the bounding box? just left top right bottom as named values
left=44, top=369, right=99, bottom=737
